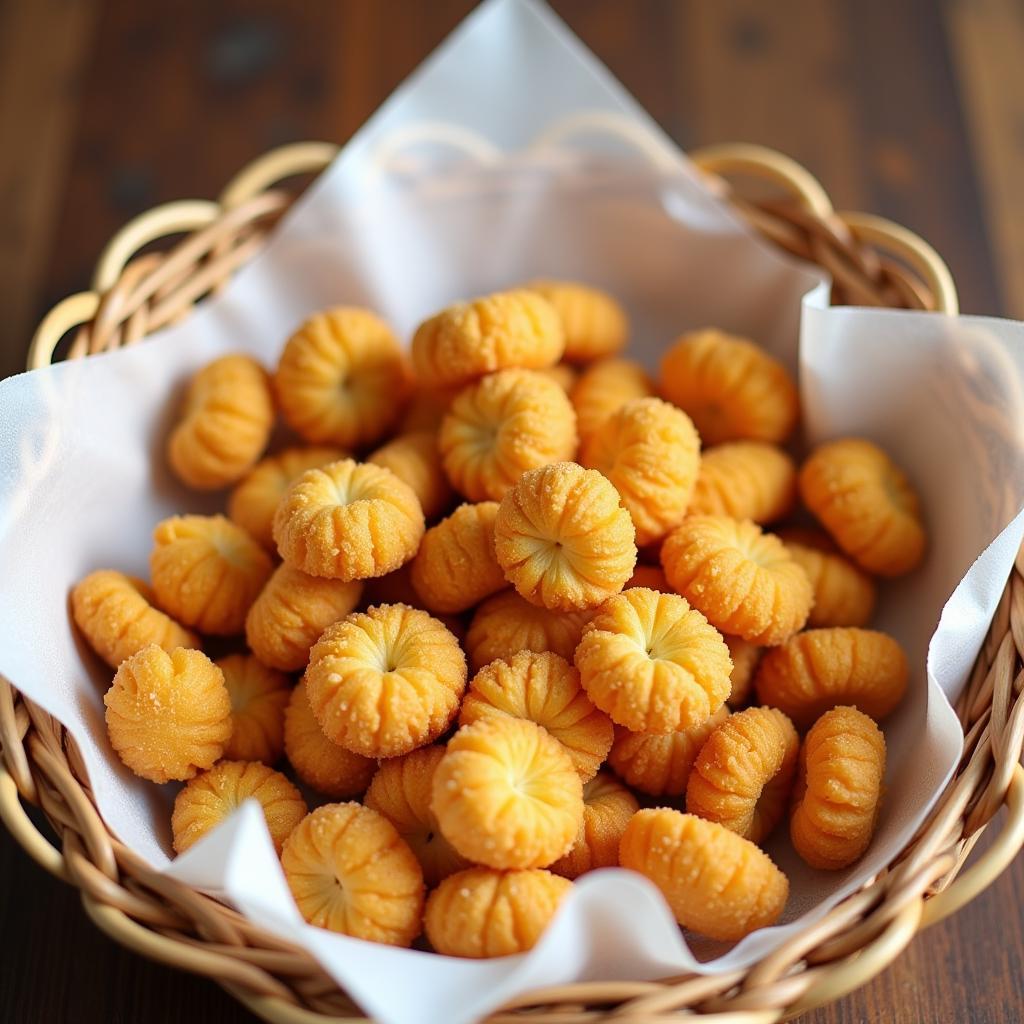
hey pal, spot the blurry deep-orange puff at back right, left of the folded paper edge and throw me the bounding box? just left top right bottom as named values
left=660, top=329, right=800, bottom=444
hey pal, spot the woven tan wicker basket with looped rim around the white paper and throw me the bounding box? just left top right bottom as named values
left=0, top=143, right=1024, bottom=1024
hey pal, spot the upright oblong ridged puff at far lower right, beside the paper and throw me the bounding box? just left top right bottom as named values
left=790, top=708, right=886, bottom=871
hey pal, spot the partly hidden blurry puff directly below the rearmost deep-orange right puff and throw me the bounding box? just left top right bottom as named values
left=687, top=441, right=797, bottom=523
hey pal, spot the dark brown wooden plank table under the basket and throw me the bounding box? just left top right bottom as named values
left=0, top=0, right=1024, bottom=1024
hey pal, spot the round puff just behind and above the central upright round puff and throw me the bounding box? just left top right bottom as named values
left=438, top=370, right=577, bottom=502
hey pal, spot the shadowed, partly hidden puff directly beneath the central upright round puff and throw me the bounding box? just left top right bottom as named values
left=466, top=590, right=590, bottom=672
